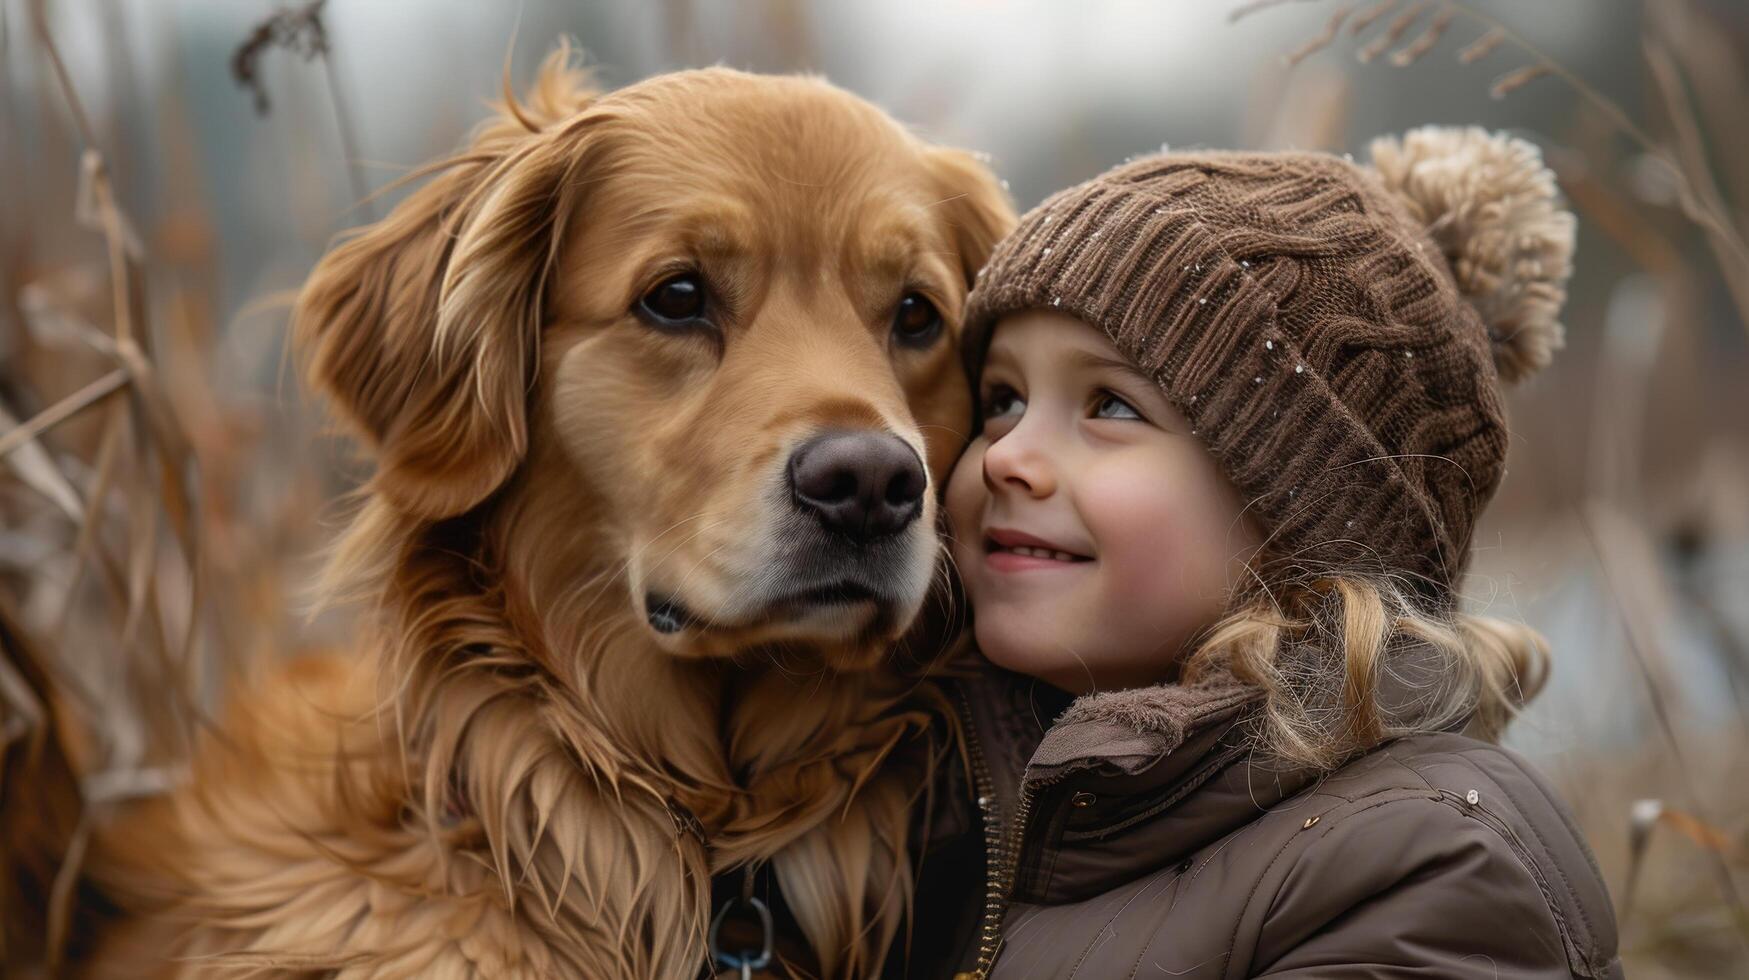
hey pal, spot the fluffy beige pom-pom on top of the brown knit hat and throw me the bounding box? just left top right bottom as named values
left=1371, top=126, right=1574, bottom=382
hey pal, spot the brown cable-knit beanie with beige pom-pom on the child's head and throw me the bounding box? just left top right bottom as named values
left=965, top=128, right=1574, bottom=600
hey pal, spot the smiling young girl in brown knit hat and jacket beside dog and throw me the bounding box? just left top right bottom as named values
left=913, top=130, right=1621, bottom=978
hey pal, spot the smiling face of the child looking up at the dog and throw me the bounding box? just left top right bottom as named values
left=948, top=312, right=1261, bottom=693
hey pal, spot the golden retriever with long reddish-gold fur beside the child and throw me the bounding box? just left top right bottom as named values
left=87, top=53, right=1013, bottom=980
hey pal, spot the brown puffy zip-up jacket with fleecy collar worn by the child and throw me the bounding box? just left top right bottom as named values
left=890, top=669, right=1621, bottom=980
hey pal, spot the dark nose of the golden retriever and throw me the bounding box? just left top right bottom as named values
left=789, top=431, right=929, bottom=543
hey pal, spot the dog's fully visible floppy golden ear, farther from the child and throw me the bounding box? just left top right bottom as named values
left=292, top=51, right=595, bottom=520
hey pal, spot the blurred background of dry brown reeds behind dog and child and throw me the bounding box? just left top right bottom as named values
left=0, top=0, right=1749, bottom=977
